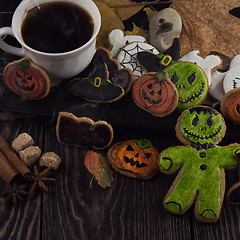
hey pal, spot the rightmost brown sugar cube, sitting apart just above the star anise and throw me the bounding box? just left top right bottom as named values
left=39, top=152, right=61, bottom=170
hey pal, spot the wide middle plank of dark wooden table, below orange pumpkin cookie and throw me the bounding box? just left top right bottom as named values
left=42, top=120, right=191, bottom=239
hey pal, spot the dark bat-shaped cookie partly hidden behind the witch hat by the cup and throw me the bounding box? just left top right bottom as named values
left=93, top=47, right=134, bottom=93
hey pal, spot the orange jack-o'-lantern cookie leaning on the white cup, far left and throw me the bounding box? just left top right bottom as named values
left=3, top=57, right=50, bottom=100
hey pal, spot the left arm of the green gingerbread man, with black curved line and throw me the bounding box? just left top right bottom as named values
left=159, top=146, right=190, bottom=174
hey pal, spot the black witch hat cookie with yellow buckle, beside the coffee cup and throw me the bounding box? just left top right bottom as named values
left=69, top=61, right=125, bottom=102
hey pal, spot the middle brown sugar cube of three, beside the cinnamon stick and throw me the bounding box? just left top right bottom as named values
left=19, top=146, right=41, bottom=166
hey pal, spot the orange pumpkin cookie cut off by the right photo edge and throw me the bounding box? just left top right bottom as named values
left=220, top=88, right=240, bottom=124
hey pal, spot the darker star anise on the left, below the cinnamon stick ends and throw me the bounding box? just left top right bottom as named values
left=1, top=182, right=28, bottom=207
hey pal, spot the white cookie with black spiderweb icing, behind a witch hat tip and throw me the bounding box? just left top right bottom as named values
left=117, top=42, right=159, bottom=80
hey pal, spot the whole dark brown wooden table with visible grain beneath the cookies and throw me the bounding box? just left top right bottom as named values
left=0, top=0, right=240, bottom=240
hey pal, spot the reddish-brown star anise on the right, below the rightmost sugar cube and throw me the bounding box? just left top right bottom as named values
left=28, top=165, right=56, bottom=194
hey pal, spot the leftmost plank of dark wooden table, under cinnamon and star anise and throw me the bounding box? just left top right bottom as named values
left=0, top=119, right=43, bottom=240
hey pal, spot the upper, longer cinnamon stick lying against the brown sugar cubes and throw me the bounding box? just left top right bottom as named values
left=0, top=135, right=31, bottom=176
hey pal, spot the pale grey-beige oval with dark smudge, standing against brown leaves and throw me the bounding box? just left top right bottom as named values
left=149, top=8, right=182, bottom=52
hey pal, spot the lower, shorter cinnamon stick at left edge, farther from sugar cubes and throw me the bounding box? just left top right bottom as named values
left=0, top=151, right=19, bottom=184
